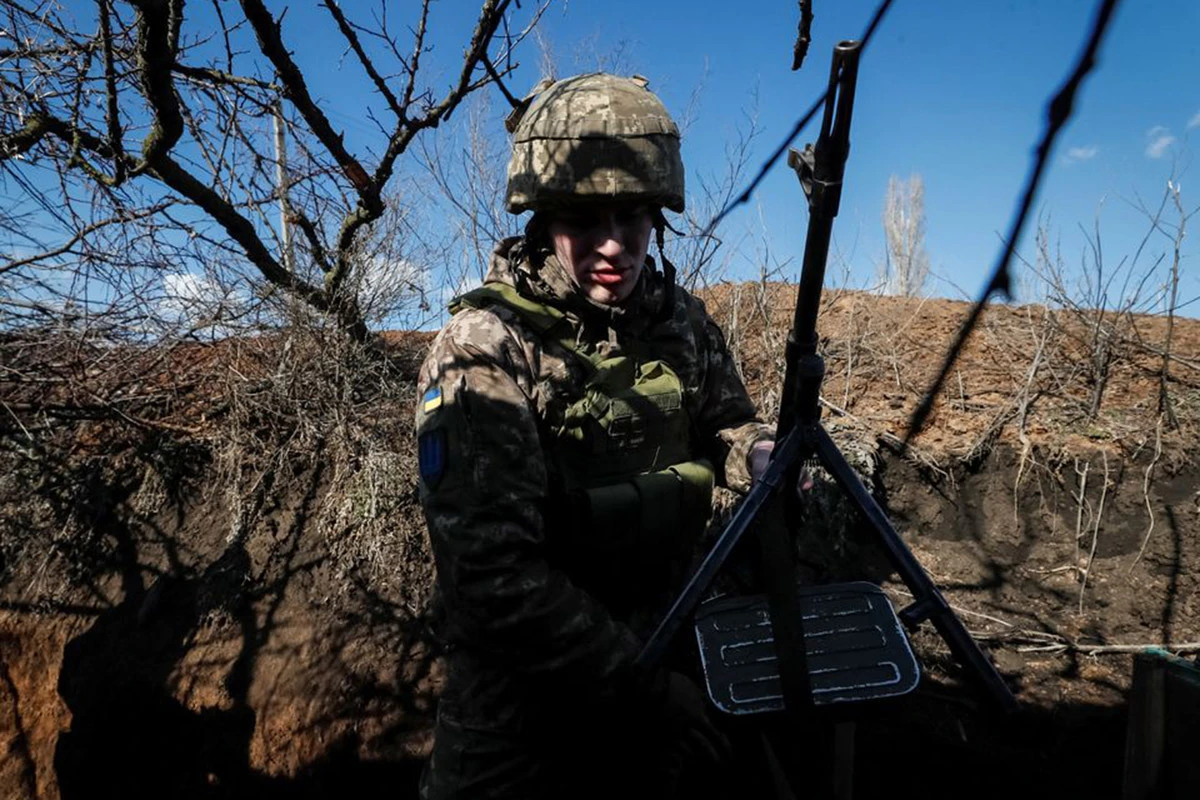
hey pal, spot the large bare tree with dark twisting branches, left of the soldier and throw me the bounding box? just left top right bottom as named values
left=0, top=0, right=544, bottom=339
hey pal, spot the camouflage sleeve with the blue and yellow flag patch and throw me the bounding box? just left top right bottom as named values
left=416, top=311, right=640, bottom=691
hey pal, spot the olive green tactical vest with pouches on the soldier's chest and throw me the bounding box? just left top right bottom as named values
left=450, top=283, right=714, bottom=609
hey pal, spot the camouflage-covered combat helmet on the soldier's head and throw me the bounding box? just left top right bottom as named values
left=505, top=72, right=683, bottom=213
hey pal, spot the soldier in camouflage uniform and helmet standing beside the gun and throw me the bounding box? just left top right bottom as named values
left=416, top=74, right=772, bottom=799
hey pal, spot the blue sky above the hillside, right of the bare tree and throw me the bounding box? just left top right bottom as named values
left=386, top=0, right=1200, bottom=313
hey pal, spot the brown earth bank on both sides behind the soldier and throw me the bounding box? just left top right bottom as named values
left=0, top=284, right=1200, bottom=799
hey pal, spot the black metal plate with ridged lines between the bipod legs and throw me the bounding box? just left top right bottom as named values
left=696, top=582, right=920, bottom=714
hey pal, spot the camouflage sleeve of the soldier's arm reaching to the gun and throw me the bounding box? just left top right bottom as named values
left=689, top=297, right=774, bottom=492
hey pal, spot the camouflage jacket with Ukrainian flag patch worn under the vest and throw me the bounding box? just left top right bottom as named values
left=416, top=239, right=770, bottom=724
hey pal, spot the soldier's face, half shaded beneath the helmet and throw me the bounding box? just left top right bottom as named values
left=550, top=204, right=654, bottom=306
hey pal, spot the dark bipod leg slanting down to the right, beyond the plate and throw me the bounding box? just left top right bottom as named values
left=812, top=426, right=1018, bottom=714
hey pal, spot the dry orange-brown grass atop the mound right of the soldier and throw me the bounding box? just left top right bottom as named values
left=704, top=283, right=1200, bottom=462
